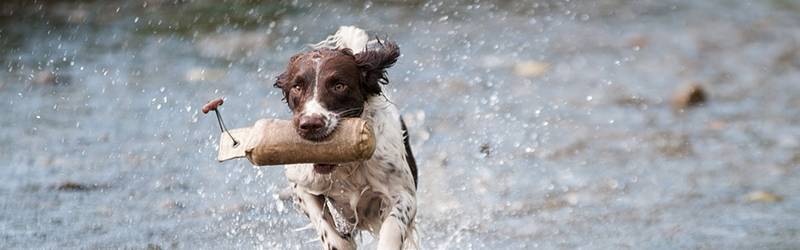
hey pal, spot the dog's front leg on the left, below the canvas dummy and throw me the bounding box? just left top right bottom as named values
left=289, top=182, right=356, bottom=250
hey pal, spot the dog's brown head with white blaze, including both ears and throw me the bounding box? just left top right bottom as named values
left=274, top=41, right=400, bottom=140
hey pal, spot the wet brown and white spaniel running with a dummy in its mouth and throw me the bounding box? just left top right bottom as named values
left=274, top=26, right=417, bottom=250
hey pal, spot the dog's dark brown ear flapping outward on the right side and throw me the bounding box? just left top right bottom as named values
left=355, top=41, right=400, bottom=97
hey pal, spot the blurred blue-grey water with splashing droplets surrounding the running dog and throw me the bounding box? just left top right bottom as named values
left=0, top=0, right=800, bottom=249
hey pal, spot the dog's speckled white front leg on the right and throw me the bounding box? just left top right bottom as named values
left=378, top=193, right=417, bottom=250
